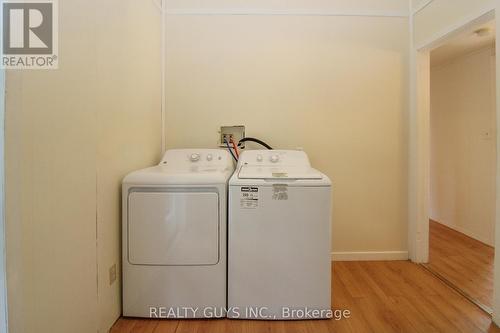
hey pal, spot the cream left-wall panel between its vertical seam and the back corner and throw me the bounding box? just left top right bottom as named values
left=96, top=0, right=161, bottom=331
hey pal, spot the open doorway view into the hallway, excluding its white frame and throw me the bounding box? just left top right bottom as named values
left=426, top=20, right=496, bottom=314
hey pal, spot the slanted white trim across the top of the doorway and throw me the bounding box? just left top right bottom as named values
left=415, top=6, right=495, bottom=51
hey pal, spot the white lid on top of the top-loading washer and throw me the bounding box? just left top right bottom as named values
left=238, top=165, right=323, bottom=179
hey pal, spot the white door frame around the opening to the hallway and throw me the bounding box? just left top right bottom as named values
left=408, top=7, right=500, bottom=323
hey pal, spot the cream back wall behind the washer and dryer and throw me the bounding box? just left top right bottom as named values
left=165, top=1, right=409, bottom=256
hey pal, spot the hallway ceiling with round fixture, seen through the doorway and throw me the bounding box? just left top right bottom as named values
left=431, top=21, right=496, bottom=66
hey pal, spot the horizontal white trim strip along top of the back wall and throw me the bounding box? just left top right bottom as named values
left=165, top=8, right=409, bottom=18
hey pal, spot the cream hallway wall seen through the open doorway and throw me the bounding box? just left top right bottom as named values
left=430, top=47, right=496, bottom=245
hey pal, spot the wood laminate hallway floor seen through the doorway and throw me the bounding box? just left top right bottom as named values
left=427, top=220, right=495, bottom=308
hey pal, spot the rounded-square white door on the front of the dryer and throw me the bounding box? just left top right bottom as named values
left=128, top=191, right=219, bottom=265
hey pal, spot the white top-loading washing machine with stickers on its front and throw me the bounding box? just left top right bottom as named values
left=228, top=150, right=332, bottom=320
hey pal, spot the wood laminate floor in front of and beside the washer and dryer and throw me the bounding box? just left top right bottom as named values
left=111, top=261, right=500, bottom=333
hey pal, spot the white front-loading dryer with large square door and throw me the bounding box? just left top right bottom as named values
left=122, top=149, right=234, bottom=318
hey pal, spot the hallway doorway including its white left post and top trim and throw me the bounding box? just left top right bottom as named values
left=409, top=10, right=500, bottom=313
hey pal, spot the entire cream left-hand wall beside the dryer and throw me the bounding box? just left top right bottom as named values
left=6, top=0, right=161, bottom=333
